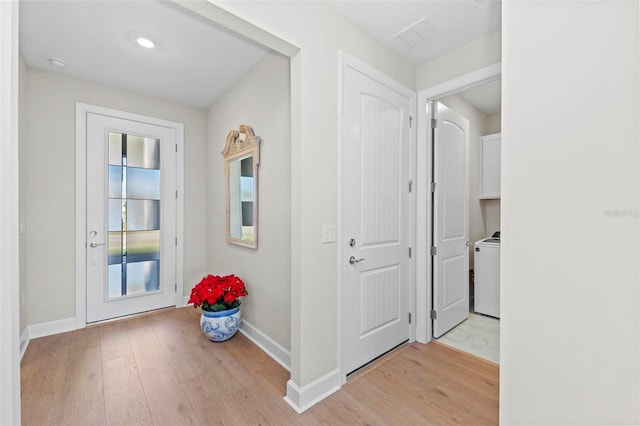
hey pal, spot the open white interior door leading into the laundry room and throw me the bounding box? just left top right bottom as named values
left=431, top=102, right=469, bottom=338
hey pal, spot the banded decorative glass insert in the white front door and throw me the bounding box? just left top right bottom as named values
left=107, top=132, right=161, bottom=300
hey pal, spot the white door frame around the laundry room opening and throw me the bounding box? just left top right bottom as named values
left=415, top=62, right=502, bottom=343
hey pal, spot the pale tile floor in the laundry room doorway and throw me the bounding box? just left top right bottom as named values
left=437, top=312, right=500, bottom=364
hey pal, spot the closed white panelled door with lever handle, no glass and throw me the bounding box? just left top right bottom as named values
left=341, top=55, right=412, bottom=373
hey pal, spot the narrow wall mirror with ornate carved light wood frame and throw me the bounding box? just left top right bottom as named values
left=222, top=124, right=261, bottom=249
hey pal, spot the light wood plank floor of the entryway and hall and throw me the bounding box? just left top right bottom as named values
left=21, top=308, right=498, bottom=426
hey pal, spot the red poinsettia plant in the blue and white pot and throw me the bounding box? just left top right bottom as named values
left=189, top=274, right=248, bottom=312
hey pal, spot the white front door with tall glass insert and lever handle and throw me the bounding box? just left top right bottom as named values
left=86, top=112, right=177, bottom=323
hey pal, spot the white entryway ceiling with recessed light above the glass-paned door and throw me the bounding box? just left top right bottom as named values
left=20, top=0, right=268, bottom=108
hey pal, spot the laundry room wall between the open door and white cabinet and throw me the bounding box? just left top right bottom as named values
left=439, top=95, right=499, bottom=269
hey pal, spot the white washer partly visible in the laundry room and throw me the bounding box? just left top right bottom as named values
left=473, top=231, right=500, bottom=318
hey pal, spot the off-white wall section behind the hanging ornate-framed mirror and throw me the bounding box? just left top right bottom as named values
left=206, top=53, right=291, bottom=350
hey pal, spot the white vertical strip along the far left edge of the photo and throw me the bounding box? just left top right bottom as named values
left=0, top=1, right=20, bottom=425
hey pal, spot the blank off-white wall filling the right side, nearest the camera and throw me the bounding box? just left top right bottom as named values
left=500, top=1, right=640, bottom=425
